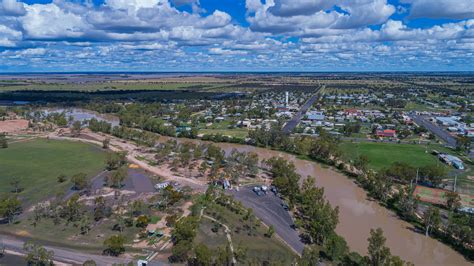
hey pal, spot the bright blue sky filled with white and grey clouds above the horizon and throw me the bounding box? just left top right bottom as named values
left=0, top=0, right=474, bottom=72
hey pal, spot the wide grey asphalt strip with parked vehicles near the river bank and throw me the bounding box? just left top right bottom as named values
left=229, top=186, right=304, bottom=254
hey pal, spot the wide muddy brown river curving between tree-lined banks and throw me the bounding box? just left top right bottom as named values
left=162, top=137, right=471, bottom=265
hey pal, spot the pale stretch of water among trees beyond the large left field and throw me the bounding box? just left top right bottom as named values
left=42, top=108, right=120, bottom=127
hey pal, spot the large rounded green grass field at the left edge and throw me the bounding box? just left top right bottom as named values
left=0, top=139, right=106, bottom=205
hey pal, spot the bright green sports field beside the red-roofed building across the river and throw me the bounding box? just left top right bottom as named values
left=341, top=142, right=441, bottom=170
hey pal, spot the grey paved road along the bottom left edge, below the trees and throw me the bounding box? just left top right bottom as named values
left=0, top=236, right=131, bottom=265
